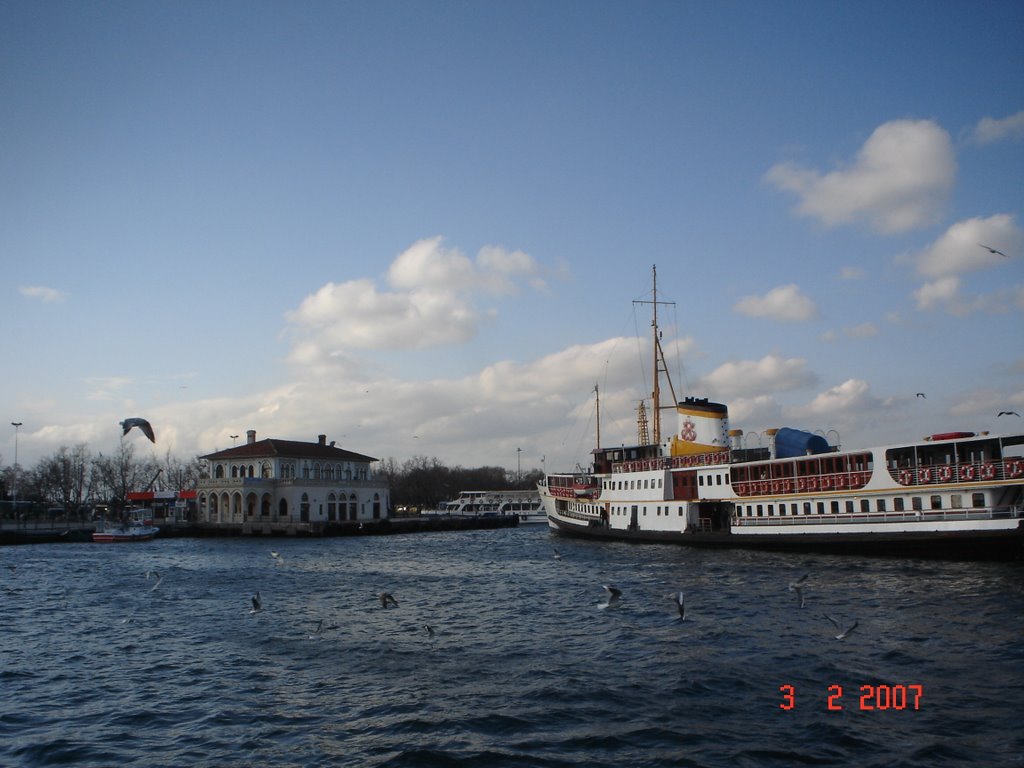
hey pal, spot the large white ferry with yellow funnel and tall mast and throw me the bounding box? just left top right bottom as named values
left=538, top=270, right=1024, bottom=558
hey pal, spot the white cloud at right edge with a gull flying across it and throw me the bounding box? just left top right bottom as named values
left=915, top=213, right=1024, bottom=278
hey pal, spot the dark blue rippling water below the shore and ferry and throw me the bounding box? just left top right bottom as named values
left=0, top=527, right=1024, bottom=768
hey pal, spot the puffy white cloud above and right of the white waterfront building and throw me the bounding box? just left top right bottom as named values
left=287, top=238, right=543, bottom=365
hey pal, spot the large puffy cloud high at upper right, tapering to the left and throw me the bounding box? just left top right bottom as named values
left=765, top=120, right=956, bottom=233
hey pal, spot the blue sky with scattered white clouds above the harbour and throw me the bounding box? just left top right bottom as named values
left=0, top=0, right=1024, bottom=481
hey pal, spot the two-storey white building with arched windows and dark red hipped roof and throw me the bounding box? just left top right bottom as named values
left=196, top=429, right=390, bottom=527
